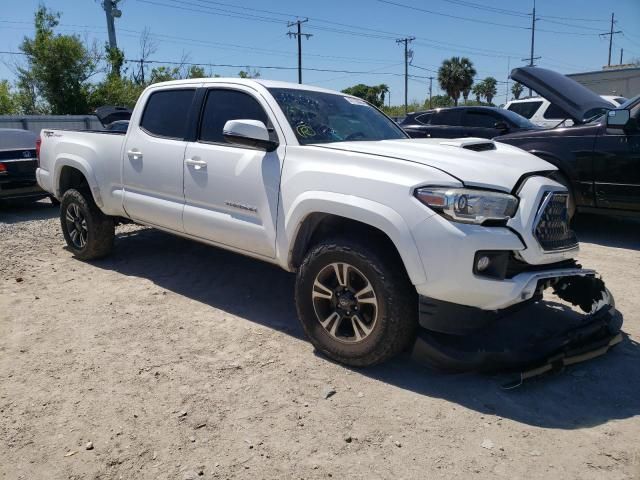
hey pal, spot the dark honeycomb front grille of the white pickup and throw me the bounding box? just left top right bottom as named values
left=534, top=192, right=578, bottom=251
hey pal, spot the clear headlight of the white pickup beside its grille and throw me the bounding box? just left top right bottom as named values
left=415, top=187, right=518, bottom=224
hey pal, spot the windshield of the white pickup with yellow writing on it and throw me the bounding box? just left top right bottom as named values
left=269, top=88, right=408, bottom=145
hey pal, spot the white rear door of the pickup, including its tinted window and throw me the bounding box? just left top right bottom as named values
left=122, top=87, right=196, bottom=231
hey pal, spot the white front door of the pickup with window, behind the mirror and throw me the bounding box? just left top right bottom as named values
left=183, top=86, right=284, bottom=257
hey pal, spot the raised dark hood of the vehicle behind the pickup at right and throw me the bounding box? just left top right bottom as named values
left=511, top=67, right=614, bottom=123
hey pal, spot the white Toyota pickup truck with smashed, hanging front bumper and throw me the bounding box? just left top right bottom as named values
left=37, top=78, right=610, bottom=366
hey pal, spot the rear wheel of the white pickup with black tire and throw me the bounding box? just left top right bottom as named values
left=60, top=189, right=115, bottom=260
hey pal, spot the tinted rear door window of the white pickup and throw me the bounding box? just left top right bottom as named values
left=140, top=89, right=195, bottom=140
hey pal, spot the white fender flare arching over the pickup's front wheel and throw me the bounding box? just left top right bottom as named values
left=278, top=191, right=426, bottom=285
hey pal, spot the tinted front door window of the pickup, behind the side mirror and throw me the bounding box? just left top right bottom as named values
left=198, top=89, right=275, bottom=143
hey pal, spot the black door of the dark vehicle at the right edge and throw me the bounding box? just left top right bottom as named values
left=593, top=108, right=640, bottom=212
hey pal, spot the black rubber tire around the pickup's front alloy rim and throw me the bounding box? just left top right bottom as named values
left=295, top=238, right=418, bottom=367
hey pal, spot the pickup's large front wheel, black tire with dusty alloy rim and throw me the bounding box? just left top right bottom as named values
left=296, top=239, right=417, bottom=367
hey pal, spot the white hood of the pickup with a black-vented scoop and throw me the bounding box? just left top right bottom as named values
left=314, top=138, right=556, bottom=192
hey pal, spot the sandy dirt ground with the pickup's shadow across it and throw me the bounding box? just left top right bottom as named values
left=0, top=201, right=640, bottom=480
